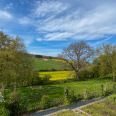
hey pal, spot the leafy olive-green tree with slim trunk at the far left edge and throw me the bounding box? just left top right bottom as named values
left=0, top=31, right=13, bottom=99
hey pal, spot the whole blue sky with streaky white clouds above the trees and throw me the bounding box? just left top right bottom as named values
left=0, top=0, right=116, bottom=56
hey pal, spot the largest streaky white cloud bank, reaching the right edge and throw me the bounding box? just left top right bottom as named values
left=34, top=4, right=116, bottom=40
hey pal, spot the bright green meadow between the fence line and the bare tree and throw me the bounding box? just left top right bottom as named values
left=0, top=78, right=116, bottom=110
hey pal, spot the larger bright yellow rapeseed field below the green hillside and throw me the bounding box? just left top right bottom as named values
left=39, top=71, right=74, bottom=80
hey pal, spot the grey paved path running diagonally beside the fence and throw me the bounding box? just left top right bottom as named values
left=28, top=97, right=106, bottom=116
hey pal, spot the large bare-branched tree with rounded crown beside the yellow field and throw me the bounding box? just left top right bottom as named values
left=58, top=41, right=94, bottom=81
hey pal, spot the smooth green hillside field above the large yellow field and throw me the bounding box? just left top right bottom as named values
left=34, top=58, right=70, bottom=70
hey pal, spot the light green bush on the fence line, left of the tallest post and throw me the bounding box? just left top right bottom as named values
left=41, top=95, right=50, bottom=109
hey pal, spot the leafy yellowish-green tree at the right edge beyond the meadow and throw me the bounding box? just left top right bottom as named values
left=96, top=44, right=116, bottom=80
